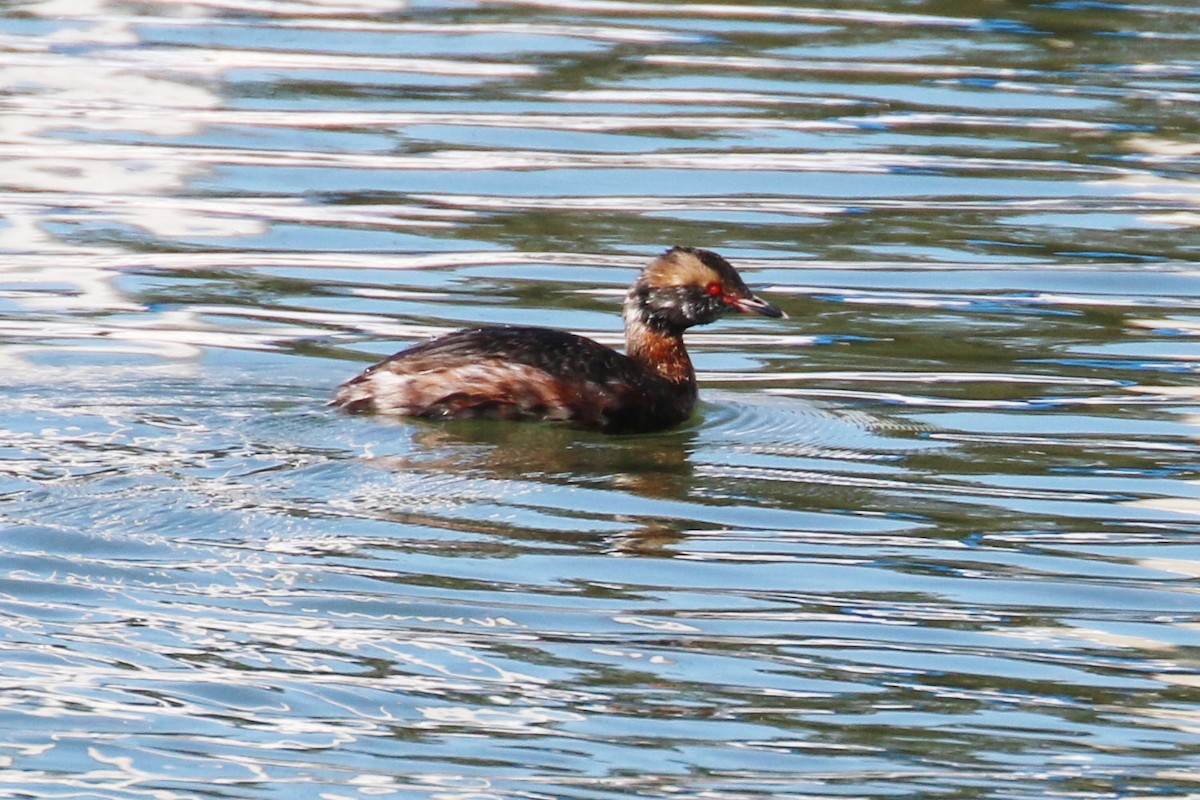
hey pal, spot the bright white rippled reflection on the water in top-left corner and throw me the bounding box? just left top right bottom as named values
left=0, top=0, right=216, bottom=347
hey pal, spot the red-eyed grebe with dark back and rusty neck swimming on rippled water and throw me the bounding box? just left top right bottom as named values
left=332, top=247, right=784, bottom=433
